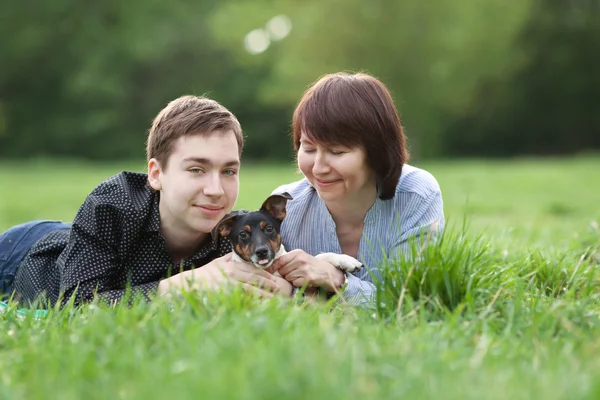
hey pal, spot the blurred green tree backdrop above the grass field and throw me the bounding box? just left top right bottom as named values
left=0, top=0, right=600, bottom=161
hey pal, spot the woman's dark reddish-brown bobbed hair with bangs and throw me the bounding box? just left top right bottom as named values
left=292, top=72, right=409, bottom=200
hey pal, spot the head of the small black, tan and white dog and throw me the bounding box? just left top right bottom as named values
left=212, top=192, right=292, bottom=268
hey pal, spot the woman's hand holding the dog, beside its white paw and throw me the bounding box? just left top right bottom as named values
left=267, top=249, right=344, bottom=292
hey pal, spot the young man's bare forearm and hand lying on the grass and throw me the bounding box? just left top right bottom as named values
left=158, top=253, right=292, bottom=297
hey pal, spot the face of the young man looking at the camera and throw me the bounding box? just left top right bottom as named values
left=148, top=130, right=240, bottom=237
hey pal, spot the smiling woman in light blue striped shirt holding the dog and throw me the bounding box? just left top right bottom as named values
left=271, top=73, right=444, bottom=304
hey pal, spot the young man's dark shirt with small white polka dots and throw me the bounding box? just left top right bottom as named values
left=14, top=172, right=232, bottom=305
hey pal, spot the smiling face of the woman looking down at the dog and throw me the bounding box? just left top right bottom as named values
left=298, top=133, right=376, bottom=202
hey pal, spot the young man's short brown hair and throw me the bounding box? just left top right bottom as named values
left=146, top=95, right=244, bottom=169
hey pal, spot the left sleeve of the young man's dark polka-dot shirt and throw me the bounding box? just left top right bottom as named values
left=57, top=193, right=158, bottom=304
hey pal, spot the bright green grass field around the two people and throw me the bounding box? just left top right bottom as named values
left=0, top=156, right=600, bottom=399
